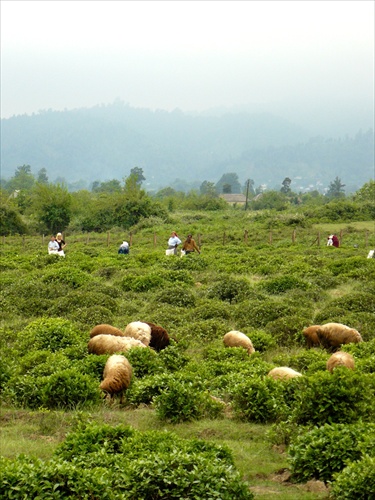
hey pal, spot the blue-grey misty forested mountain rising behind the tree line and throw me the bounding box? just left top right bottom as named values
left=1, top=100, right=374, bottom=190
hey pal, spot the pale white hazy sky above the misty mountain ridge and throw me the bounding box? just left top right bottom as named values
left=0, top=0, right=375, bottom=135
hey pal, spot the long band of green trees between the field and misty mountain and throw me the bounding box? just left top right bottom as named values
left=0, top=165, right=375, bottom=235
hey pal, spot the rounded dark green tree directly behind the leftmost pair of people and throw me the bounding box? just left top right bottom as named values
left=31, top=183, right=72, bottom=233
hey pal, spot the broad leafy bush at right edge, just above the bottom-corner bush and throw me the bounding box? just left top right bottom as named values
left=289, top=423, right=375, bottom=482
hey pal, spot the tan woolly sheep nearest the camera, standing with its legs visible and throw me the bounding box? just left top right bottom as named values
left=100, top=354, right=133, bottom=402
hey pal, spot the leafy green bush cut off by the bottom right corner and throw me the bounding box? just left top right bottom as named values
left=330, top=455, right=375, bottom=500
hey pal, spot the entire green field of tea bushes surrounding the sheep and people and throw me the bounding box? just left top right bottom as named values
left=0, top=210, right=375, bottom=500
